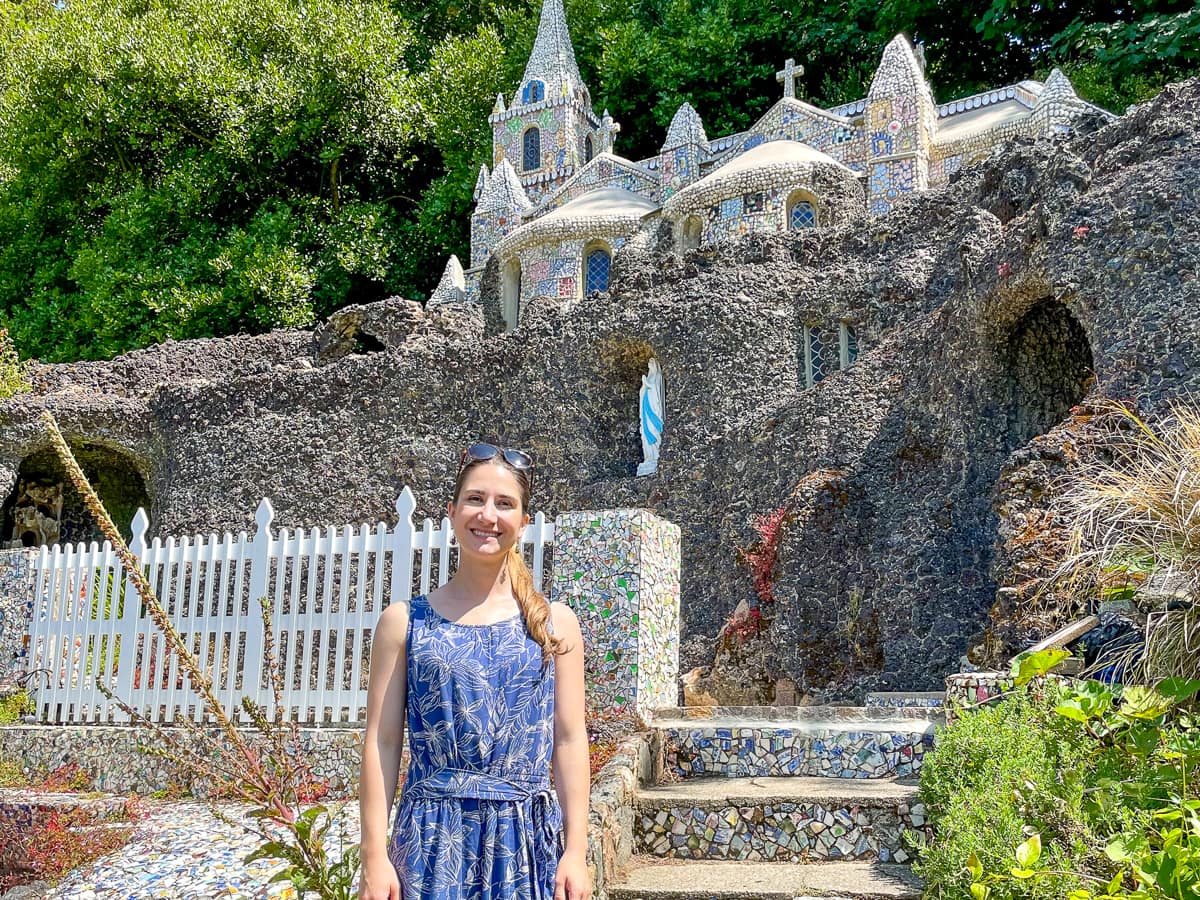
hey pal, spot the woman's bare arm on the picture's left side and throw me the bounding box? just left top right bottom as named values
left=359, top=602, right=408, bottom=900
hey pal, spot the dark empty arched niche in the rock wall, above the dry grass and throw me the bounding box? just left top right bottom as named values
left=1006, top=299, right=1094, bottom=448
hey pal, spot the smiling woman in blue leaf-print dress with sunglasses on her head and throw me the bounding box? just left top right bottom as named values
left=359, top=444, right=590, bottom=900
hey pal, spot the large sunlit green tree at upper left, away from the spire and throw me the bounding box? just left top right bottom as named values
left=0, top=0, right=428, bottom=359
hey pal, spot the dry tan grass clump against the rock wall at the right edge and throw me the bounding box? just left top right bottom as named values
left=1051, top=401, right=1200, bottom=684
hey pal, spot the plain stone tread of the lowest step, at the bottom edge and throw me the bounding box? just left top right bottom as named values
left=608, top=857, right=920, bottom=900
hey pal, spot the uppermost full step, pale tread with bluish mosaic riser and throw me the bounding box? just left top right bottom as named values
left=652, top=707, right=942, bottom=778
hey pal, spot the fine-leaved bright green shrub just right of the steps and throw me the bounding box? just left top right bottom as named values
left=914, top=689, right=1092, bottom=900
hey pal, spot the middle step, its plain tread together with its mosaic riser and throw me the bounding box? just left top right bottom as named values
left=634, top=778, right=925, bottom=863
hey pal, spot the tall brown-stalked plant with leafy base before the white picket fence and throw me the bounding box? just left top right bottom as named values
left=42, top=412, right=359, bottom=900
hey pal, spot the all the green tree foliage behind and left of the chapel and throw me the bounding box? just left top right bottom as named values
left=0, top=0, right=1200, bottom=360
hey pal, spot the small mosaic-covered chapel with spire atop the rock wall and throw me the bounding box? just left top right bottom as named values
left=430, top=0, right=1111, bottom=329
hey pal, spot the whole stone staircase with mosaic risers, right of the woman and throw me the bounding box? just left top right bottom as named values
left=607, top=694, right=942, bottom=900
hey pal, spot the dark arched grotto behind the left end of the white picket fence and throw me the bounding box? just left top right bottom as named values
left=0, top=443, right=150, bottom=547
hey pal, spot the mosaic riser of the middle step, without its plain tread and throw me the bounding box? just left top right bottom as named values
left=636, top=799, right=925, bottom=863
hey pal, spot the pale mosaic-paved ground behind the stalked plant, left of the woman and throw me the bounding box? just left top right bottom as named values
left=44, top=803, right=359, bottom=900
